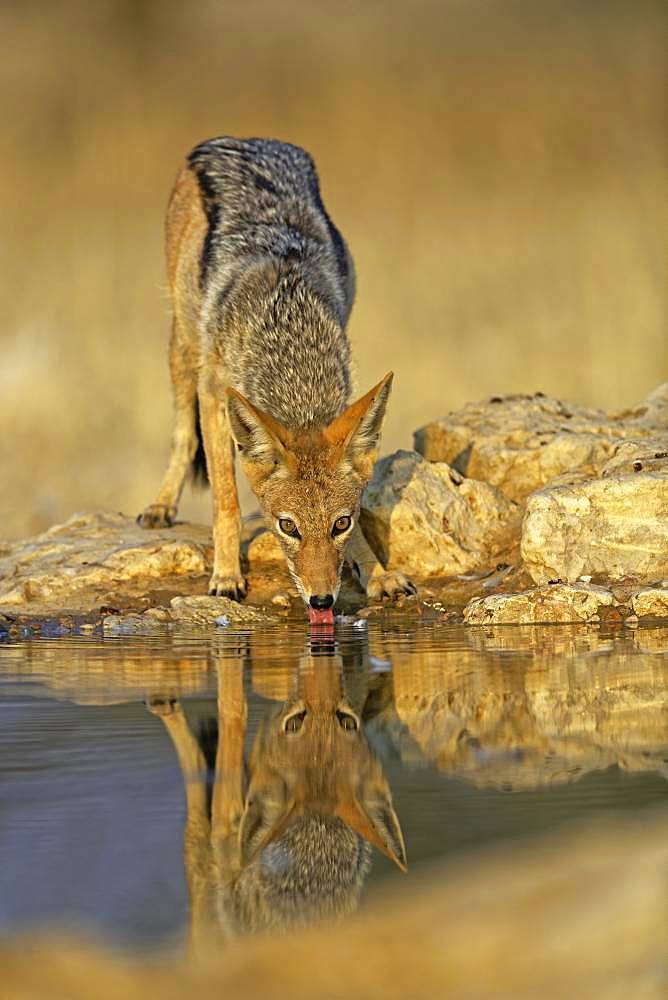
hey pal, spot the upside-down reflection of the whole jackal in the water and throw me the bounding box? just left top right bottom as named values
left=148, top=655, right=406, bottom=947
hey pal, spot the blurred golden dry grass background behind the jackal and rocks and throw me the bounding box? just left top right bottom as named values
left=0, top=0, right=668, bottom=536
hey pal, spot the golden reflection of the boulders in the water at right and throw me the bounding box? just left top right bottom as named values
left=374, top=628, right=668, bottom=790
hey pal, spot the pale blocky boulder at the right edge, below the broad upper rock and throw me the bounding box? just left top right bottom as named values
left=521, top=470, right=668, bottom=584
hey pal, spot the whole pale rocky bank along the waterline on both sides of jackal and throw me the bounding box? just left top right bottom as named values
left=0, top=383, right=668, bottom=633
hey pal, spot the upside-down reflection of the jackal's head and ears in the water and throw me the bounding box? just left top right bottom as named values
left=239, top=656, right=406, bottom=876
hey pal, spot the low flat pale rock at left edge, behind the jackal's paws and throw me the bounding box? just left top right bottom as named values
left=0, top=514, right=211, bottom=609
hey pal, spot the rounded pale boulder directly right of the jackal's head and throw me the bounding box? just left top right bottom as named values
left=362, top=451, right=519, bottom=578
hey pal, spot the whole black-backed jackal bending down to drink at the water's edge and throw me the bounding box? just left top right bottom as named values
left=139, top=137, right=415, bottom=621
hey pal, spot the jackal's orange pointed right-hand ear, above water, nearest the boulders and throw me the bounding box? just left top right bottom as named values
left=324, top=372, right=394, bottom=480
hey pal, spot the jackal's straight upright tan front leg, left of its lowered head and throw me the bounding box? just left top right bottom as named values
left=197, top=366, right=246, bottom=601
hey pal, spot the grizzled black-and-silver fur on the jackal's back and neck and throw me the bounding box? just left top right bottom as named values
left=188, top=137, right=354, bottom=429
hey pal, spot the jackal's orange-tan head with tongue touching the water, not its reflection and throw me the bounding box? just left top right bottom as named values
left=228, top=372, right=392, bottom=621
